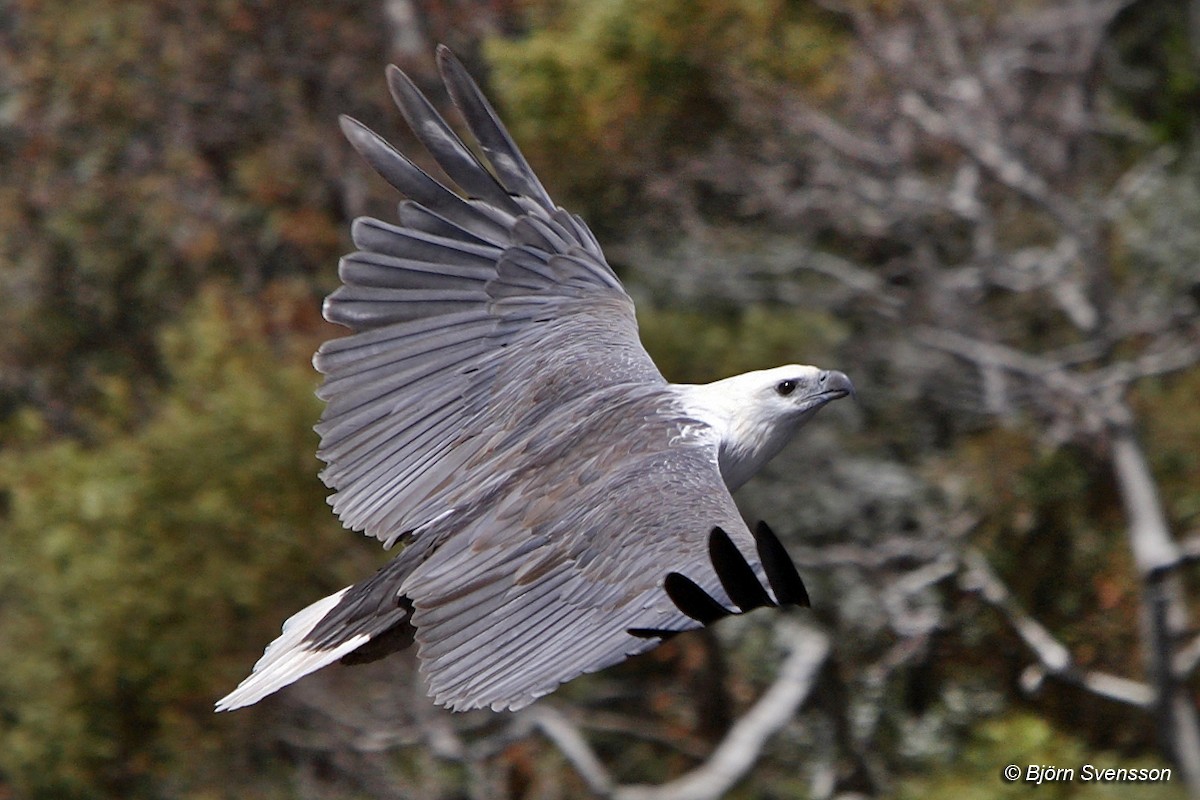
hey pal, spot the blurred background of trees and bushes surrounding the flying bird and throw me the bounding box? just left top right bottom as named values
left=0, top=0, right=1200, bottom=800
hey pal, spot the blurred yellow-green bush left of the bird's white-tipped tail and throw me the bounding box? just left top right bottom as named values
left=0, top=281, right=372, bottom=798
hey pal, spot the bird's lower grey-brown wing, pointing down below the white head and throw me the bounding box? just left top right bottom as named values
left=379, top=395, right=774, bottom=708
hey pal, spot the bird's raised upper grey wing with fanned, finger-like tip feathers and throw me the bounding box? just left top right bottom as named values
left=314, top=48, right=665, bottom=543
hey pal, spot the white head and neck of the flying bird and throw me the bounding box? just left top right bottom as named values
left=680, top=363, right=854, bottom=491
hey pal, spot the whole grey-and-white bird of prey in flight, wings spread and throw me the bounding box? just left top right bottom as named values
left=217, top=47, right=853, bottom=710
